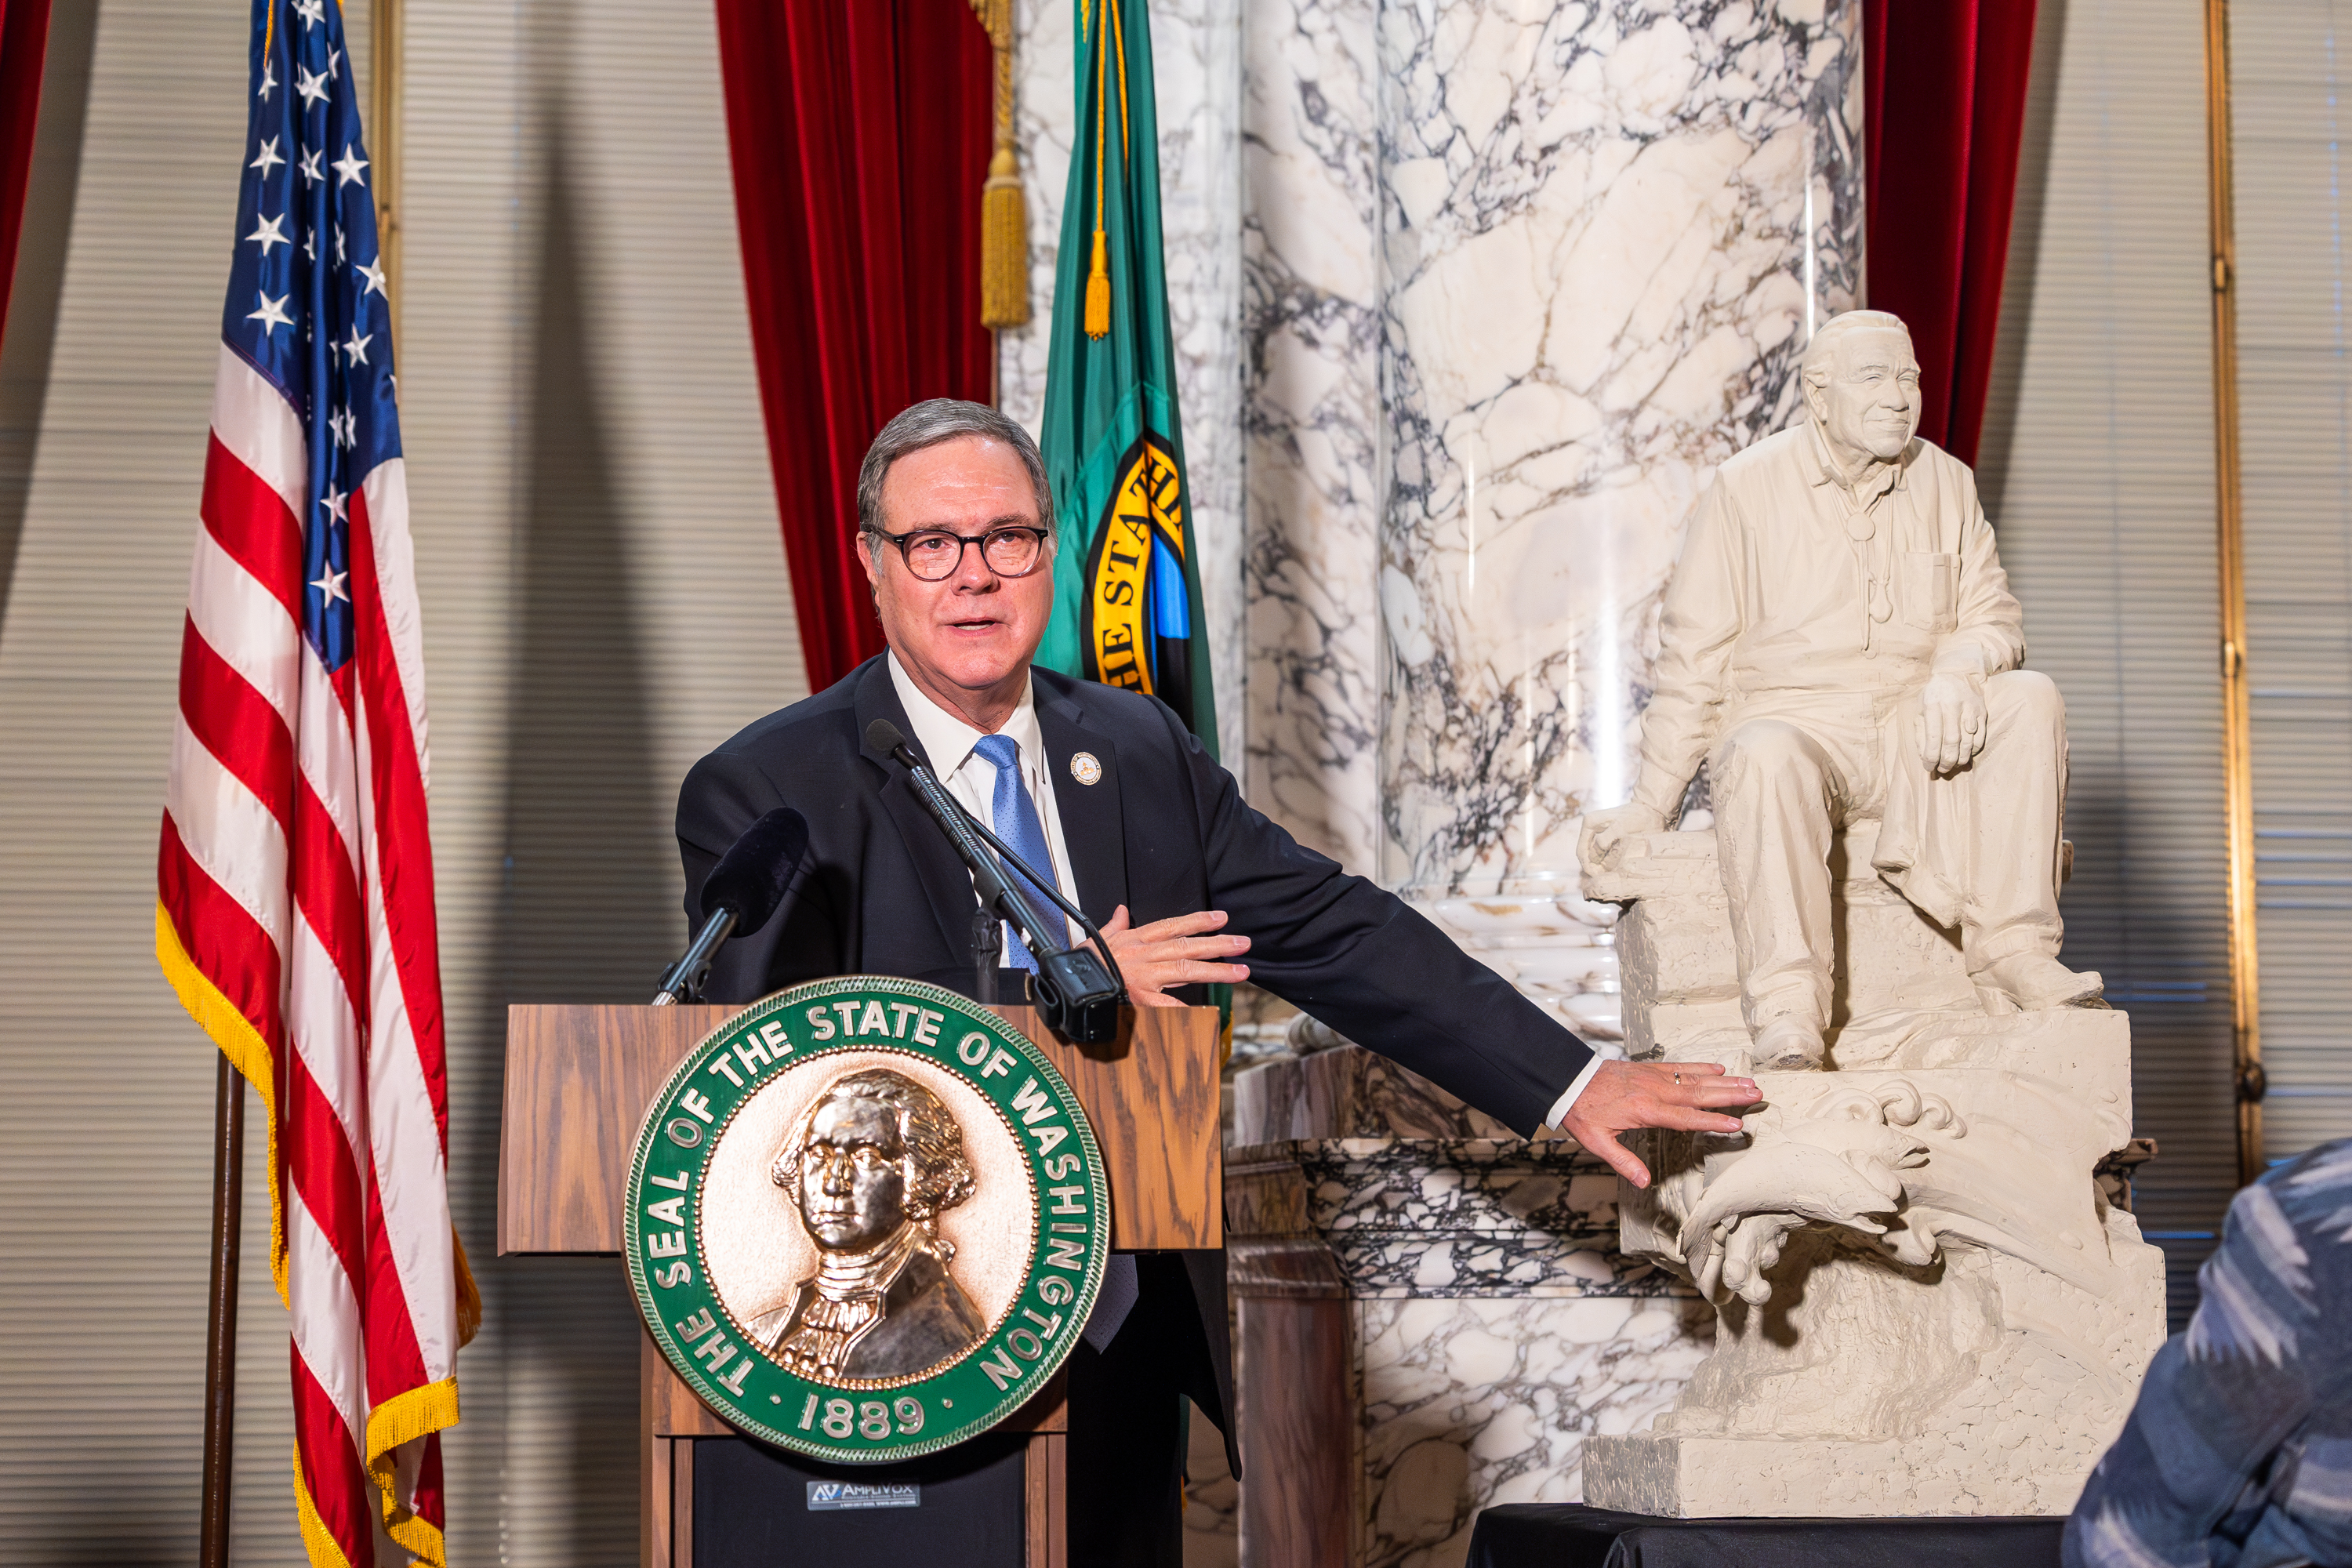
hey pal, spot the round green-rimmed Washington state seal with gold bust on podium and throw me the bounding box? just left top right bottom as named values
left=623, top=975, right=1110, bottom=1462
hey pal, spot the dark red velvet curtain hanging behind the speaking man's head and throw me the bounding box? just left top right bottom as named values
left=717, top=0, right=993, bottom=691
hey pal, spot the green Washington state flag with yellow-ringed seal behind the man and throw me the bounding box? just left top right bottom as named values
left=1037, top=0, right=1216, bottom=757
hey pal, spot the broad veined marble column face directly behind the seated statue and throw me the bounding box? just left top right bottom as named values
left=1378, top=0, right=1863, bottom=1034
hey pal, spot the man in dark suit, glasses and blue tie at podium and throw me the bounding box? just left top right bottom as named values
left=677, top=400, right=1755, bottom=1568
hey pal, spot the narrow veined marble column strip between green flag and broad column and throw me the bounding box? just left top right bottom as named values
left=1242, top=0, right=1385, bottom=874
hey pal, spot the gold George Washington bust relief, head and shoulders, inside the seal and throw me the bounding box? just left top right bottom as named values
left=746, top=1067, right=988, bottom=1382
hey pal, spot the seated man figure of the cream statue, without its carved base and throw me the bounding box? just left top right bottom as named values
left=1583, top=310, right=2100, bottom=1069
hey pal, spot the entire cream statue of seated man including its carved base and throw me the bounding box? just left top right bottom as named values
left=1581, top=310, right=2164, bottom=1516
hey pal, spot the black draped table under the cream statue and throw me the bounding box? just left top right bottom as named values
left=1468, top=1502, right=2065, bottom=1568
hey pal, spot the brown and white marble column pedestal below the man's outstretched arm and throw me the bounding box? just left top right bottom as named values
left=1225, top=1046, right=1712, bottom=1568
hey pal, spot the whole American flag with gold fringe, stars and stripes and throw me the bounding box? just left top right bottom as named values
left=155, top=0, right=470, bottom=1568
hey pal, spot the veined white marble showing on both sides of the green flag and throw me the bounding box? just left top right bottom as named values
left=997, top=0, right=1247, bottom=771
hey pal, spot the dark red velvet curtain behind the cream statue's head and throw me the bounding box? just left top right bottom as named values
left=1863, top=0, right=2034, bottom=463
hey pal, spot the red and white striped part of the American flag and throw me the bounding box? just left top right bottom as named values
left=158, top=348, right=459, bottom=1568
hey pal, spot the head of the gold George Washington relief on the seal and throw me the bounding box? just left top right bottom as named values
left=771, top=1067, right=974, bottom=1253
